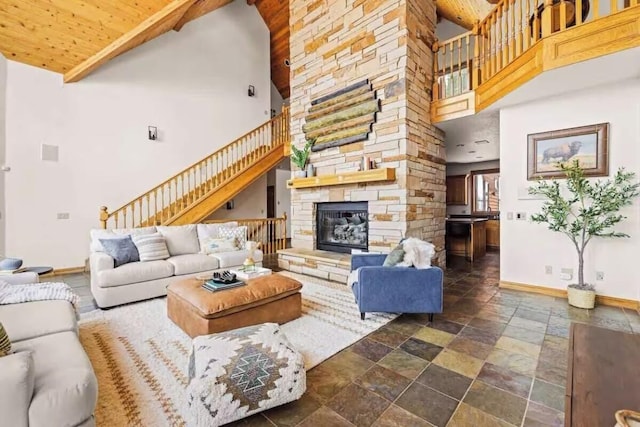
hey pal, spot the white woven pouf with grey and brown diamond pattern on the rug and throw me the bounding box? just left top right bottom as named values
left=187, top=323, right=307, bottom=426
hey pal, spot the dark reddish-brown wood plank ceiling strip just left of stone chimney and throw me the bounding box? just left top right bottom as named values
left=247, top=0, right=289, bottom=99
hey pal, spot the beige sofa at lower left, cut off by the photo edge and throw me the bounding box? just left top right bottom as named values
left=0, top=273, right=98, bottom=427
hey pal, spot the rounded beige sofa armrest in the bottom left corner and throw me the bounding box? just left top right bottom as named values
left=0, top=351, right=35, bottom=427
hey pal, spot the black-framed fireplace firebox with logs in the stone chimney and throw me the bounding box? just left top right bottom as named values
left=316, top=202, right=369, bottom=253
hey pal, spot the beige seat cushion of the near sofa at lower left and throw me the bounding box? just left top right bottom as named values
left=16, top=332, right=98, bottom=427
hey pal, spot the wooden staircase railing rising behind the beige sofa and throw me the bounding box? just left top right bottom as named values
left=100, top=107, right=290, bottom=229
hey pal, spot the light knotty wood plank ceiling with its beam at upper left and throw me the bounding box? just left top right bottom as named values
left=0, top=0, right=232, bottom=82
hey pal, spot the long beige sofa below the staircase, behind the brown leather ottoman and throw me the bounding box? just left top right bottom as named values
left=89, top=222, right=263, bottom=308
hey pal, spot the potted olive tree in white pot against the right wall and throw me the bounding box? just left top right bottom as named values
left=529, top=160, right=640, bottom=308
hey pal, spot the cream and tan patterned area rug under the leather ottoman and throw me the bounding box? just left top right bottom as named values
left=80, top=272, right=396, bottom=426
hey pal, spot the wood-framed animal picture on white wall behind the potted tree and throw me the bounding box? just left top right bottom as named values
left=527, top=123, right=609, bottom=180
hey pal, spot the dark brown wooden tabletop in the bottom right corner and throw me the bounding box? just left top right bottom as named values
left=565, top=323, right=640, bottom=427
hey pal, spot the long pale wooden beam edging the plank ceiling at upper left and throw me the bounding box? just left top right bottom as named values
left=64, top=0, right=195, bottom=83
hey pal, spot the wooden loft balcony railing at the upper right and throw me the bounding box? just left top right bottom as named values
left=432, top=0, right=640, bottom=101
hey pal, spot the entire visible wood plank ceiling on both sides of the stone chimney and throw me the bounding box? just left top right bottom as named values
left=0, top=0, right=492, bottom=99
